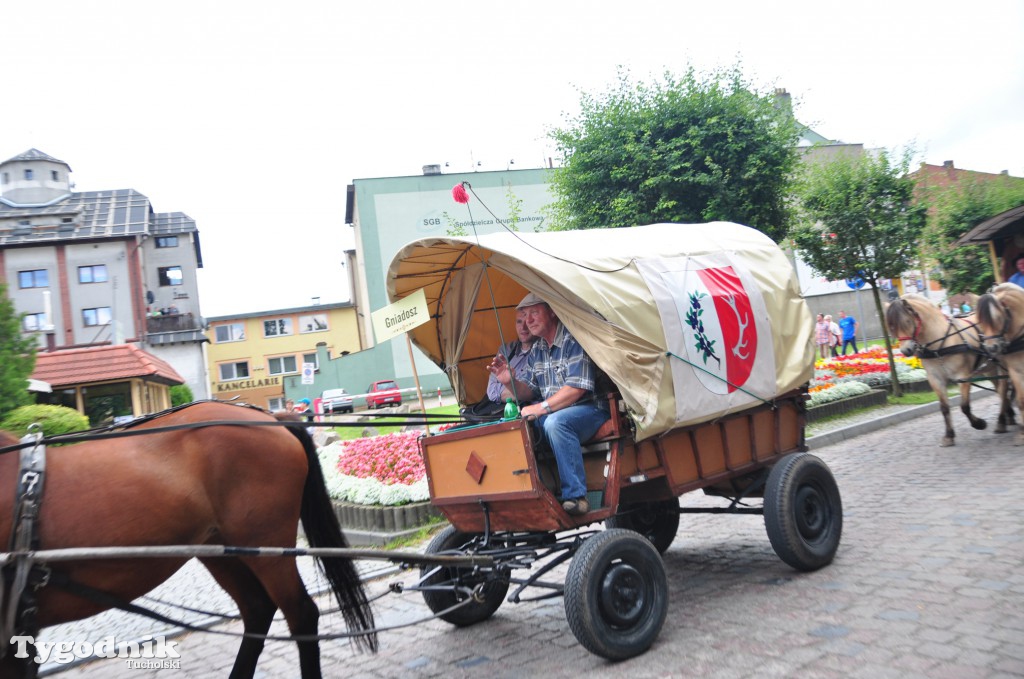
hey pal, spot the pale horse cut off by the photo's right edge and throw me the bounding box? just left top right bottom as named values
left=977, top=283, right=1024, bottom=445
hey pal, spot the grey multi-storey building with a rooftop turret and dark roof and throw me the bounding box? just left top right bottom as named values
left=0, top=148, right=209, bottom=398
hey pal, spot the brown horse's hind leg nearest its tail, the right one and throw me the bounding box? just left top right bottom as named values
left=246, top=558, right=322, bottom=679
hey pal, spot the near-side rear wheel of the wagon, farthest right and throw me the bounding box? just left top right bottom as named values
left=764, top=453, right=843, bottom=570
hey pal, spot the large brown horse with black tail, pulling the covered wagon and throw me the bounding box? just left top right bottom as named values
left=0, top=402, right=377, bottom=679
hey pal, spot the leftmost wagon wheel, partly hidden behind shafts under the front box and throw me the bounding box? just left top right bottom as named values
left=420, top=525, right=509, bottom=627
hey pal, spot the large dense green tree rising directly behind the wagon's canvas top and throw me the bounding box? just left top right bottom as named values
left=549, top=67, right=800, bottom=242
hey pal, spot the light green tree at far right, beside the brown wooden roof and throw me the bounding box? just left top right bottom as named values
left=923, top=177, right=1024, bottom=294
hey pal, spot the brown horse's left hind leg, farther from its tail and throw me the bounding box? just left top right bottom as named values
left=201, top=558, right=278, bottom=679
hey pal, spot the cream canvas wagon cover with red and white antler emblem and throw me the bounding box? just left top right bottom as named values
left=387, top=222, right=814, bottom=440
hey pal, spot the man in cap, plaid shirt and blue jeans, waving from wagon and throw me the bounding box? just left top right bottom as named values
left=487, top=293, right=608, bottom=516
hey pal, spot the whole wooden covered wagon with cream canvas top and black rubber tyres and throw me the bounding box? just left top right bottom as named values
left=387, top=222, right=842, bottom=657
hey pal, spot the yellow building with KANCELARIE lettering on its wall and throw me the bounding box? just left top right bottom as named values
left=207, top=302, right=362, bottom=411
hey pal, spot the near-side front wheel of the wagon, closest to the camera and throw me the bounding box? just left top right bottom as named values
left=564, top=528, right=669, bottom=660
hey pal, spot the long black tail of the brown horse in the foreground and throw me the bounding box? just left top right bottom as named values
left=289, top=426, right=378, bottom=652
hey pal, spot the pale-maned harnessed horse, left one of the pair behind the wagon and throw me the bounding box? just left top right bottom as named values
left=886, top=293, right=1013, bottom=445
